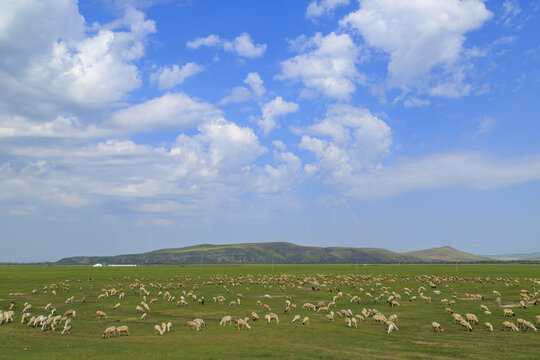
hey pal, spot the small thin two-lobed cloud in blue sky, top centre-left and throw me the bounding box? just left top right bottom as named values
left=186, top=33, right=267, bottom=59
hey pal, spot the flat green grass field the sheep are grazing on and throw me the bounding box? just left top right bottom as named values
left=0, top=265, right=540, bottom=360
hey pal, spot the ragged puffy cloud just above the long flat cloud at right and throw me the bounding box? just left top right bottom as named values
left=293, top=105, right=392, bottom=183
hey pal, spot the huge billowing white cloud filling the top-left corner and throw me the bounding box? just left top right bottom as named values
left=0, top=1, right=155, bottom=121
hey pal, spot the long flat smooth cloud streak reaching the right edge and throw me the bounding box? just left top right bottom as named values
left=341, top=152, right=540, bottom=199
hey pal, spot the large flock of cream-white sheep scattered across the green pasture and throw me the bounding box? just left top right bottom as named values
left=0, top=274, right=540, bottom=339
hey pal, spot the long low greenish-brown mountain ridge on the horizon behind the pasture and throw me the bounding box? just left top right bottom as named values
left=56, top=242, right=489, bottom=265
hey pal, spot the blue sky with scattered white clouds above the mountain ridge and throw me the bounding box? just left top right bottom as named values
left=0, top=0, right=540, bottom=261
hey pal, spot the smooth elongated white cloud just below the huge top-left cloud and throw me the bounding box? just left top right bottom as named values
left=112, top=93, right=222, bottom=132
